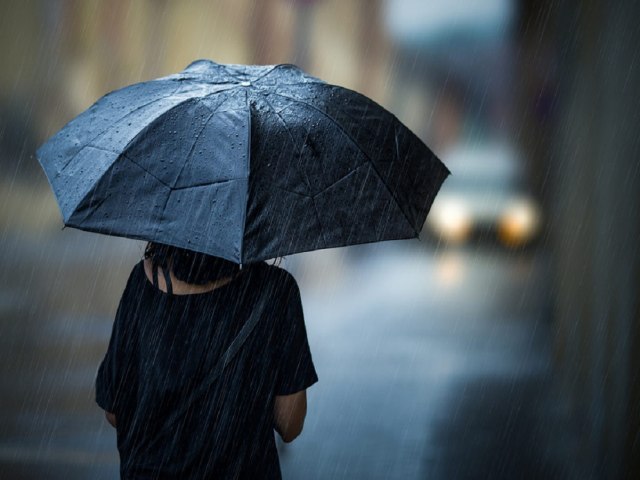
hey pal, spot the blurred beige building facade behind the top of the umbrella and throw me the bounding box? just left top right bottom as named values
left=0, top=0, right=392, bottom=152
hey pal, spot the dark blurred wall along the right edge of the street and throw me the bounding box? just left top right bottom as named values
left=520, top=0, right=640, bottom=479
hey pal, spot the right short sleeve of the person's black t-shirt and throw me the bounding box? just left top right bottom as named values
left=275, top=275, right=318, bottom=395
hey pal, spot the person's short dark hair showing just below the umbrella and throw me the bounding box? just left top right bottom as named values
left=144, top=242, right=240, bottom=285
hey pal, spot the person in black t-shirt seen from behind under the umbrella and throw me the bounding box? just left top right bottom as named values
left=96, top=243, right=318, bottom=480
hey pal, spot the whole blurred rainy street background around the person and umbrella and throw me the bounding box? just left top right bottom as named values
left=0, top=0, right=640, bottom=480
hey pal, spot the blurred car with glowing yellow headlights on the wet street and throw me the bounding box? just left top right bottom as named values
left=423, top=142, right=542, bottom=247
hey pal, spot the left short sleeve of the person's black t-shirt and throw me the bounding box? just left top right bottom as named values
left=95, top=262, right=135, bottom=413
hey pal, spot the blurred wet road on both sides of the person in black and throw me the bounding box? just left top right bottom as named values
left=0, top=231, right=573, bottom=480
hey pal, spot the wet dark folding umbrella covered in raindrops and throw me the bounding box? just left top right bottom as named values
left=37, top=60, right=451, bottom=263
